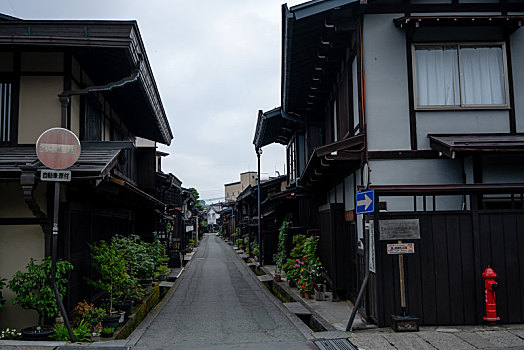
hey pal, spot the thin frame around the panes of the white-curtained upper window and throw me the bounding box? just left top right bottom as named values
left=411, top=41, right=511, bottom=111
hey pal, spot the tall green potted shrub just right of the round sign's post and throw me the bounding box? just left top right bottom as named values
left=88, top=241, right=129, bottom=328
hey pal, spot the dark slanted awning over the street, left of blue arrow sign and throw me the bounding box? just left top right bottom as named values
left=300, top=134, right=364, bottom=187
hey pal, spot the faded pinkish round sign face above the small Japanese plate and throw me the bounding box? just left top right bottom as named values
left=36, top=128, right=80, bottom=170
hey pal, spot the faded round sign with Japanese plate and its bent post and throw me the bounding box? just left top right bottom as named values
left=36, top=128, right=80, bottom=342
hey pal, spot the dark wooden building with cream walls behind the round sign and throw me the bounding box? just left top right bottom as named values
left=0, top=16, right=176, bottom=328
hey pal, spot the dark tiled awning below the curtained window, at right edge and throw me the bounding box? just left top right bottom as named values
left=428, top=134, right=524, bottom=158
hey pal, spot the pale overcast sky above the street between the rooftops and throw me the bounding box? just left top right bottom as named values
left=0, top=0, right=304, bottom=199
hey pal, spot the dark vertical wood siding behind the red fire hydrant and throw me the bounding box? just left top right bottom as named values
left=373, top=211, right=524, bottom=326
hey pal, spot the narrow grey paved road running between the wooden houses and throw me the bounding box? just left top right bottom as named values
left=130, top=235, right=316, bottom=350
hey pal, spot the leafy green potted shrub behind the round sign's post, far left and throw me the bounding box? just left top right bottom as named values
left=7, top=257, right=73, bottom=340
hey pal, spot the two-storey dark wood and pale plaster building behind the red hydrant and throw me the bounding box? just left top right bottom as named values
left=254, top=0, right=524, bottom=326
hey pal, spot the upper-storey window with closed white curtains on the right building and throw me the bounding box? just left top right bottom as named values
left=414, top=44, right=508, bottom=108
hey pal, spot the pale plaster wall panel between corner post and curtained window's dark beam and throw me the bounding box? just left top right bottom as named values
left=364, top=14, right=411, bottom=151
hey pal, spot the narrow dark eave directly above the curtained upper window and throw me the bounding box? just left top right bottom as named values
left=393, top=15, right=524, bottom=33
